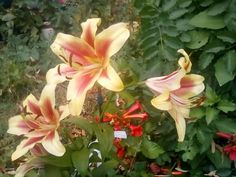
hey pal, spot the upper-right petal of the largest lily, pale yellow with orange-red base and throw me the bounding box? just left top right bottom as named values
left=95, top=23, right=130, bottom=59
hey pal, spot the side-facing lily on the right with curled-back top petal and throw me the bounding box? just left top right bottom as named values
left=146, top=49, right=205, bottom=142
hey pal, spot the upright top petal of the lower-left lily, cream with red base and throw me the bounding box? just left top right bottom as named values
left=40, top=84, right=59, bottom=123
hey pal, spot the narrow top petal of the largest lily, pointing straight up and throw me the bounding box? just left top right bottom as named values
left=81, top=18, right=101, bottom=47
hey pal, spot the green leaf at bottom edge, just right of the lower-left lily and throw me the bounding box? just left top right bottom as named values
left=71, top=147, right=90, bottom=176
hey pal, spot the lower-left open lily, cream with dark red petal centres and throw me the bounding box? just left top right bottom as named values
left=7, top=85, right=68, bottom=160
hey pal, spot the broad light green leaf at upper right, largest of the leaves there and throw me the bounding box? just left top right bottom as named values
left=189, top=11, right=225, bottom=29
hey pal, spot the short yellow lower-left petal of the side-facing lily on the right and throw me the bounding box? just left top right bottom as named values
left=151, top=92, right=172, bottom=111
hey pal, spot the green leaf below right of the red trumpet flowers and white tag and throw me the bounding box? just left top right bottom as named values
left=141, top=138, right=164, bottom=159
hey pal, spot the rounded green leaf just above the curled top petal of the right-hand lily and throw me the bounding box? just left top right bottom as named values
left=186, top=30, right=209, bottom=49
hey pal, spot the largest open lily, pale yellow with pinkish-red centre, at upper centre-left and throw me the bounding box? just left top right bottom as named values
left=46, top=18, right=130, bottom=115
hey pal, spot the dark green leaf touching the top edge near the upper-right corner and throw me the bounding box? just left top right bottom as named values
left=207, top=0, right=230, bottom=16
